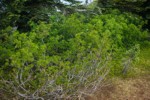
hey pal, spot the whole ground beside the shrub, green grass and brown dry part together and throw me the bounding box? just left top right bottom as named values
left=86, top=48, right=150, bottom=100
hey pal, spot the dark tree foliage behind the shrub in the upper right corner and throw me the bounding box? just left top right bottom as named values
left=97, top=0, right=150, bottom=28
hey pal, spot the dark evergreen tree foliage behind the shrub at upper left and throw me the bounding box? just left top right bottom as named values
left=0, top=0, right=79, bottom=31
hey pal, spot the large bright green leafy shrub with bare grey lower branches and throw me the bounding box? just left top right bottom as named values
left=0, top=12, right=146, bottom=99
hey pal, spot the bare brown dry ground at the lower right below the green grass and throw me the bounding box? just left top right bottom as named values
left=86, top=75, right=150, bottom=100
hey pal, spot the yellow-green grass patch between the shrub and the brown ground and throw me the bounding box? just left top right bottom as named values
left=110, top=45, right=150, bottom=78
